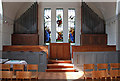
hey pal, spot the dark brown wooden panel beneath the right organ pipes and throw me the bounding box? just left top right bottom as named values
left=80, top=34, right=107, bottom=45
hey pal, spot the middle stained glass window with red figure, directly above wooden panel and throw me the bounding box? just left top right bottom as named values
left=56, top=8, right=63, bottom=42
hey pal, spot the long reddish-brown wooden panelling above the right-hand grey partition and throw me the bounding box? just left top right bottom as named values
left=72, top=45, right=116, bottom=57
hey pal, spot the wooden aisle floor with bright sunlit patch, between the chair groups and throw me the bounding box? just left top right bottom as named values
left=38, top=71, right=84, bottom=80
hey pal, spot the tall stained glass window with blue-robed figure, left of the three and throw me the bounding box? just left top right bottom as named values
left=44, top=8, right=51, bottom=43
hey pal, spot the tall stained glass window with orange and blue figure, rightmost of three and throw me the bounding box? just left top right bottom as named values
left=68, top=8, right=75, bottom=43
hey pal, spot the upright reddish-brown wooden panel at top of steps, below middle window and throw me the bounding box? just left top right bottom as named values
left=50, top=43, right=70, bottom=60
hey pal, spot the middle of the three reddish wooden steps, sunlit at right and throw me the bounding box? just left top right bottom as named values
left=47, top=63, right=74, bottom=69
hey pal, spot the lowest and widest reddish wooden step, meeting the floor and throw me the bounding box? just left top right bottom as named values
left=46, top=68, right=76, bottom=72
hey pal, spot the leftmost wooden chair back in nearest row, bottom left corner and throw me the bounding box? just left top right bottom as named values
left=0, top=71, right=13, bottom=80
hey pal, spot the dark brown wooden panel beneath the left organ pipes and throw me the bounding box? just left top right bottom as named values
left=12, top=34, right=39, bottom=45
